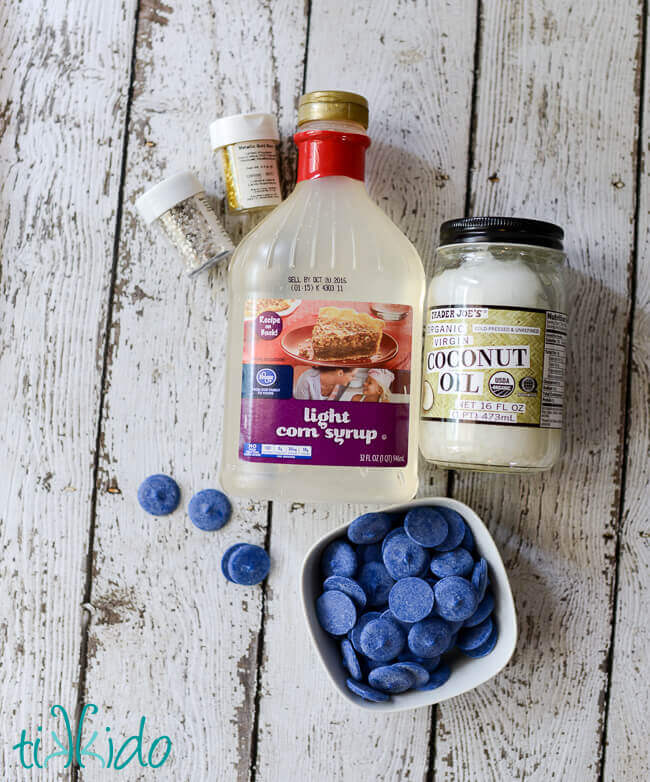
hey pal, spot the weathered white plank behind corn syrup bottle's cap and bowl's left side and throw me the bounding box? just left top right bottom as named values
left=257, top=0, right=476, bottom=781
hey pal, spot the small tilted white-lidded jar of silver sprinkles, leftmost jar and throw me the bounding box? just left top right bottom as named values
left=135, top=171, right=235, bottom=277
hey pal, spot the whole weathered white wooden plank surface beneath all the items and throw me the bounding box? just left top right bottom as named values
left=0, top=0, right=650, bottom=782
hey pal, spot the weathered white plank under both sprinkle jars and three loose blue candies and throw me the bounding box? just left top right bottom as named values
left=77, top=0, right=305, bottom=780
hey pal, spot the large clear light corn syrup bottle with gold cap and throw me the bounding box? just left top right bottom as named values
left=221, top=91, right=425, bottom=503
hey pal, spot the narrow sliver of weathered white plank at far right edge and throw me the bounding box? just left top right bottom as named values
left=604, top=4, right=650, bottom=782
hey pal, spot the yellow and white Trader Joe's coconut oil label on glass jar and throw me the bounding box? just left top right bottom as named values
left=421, top=304, right=567, bottom=429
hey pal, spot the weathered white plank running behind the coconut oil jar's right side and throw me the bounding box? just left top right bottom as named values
left=435, top=0, right=640, bottom=782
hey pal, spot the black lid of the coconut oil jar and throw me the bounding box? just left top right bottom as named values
left=440, top=217, right=564, bottom=250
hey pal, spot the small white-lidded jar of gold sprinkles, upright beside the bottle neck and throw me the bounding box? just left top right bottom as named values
left=210, top=114, right=282, bottom=214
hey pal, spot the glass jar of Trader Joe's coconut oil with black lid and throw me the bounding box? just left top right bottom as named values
left=420, top=217, right=567, bottom=472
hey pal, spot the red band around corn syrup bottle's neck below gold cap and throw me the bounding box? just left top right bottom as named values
left=293, top=130, right=370, bottom=182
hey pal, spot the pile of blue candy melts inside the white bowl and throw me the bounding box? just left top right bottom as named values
left=316, top=506, right=498, bottom=703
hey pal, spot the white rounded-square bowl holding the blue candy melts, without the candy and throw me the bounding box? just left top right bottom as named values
left=301, top=497, right=517, bottom=712
